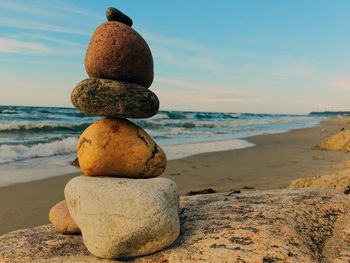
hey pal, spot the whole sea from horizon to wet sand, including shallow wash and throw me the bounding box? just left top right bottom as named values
left=0, top=106, right=329, bottom=186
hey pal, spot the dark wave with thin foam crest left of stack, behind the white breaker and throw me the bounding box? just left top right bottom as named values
left=0, top=121, right=91, bottom=133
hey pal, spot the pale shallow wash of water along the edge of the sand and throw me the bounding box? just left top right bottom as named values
left=0, top=120, right=322, bottom=188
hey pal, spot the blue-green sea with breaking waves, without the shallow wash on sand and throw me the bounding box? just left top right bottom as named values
left=0, top=106, right=319, bottom=164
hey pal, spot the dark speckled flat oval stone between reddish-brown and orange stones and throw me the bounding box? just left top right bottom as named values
left=71, top=79, right=159, bottom=118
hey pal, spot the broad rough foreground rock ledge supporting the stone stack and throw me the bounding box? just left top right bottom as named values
left=0, top=190, right=350, bottom=263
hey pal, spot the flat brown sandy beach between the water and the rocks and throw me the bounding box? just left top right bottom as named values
left=0, top=121, right=349, bottom=234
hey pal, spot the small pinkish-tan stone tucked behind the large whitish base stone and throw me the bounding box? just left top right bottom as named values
left=49, top=200, right=80, bottom=234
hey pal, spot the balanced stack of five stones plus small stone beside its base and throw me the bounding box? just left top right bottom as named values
left=50, top=8, right=180, bottom=258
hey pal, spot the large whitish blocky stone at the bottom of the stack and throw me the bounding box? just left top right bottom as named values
left=64, top=176, right=180, bottom=258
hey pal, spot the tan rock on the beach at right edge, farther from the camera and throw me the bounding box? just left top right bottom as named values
left=316, top=130, right=350, bottom=152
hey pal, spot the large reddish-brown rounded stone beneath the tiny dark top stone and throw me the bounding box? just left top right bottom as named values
left=85, top=21, right=153, bottom=88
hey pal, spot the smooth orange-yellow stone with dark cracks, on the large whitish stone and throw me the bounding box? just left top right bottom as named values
left=78, top=118, right=167, bottom=178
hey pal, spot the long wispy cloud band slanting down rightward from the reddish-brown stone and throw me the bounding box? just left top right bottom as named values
left=142, top=30, right=294, bottom=78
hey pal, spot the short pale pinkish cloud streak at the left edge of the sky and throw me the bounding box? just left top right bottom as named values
left=0, top=38, right=50, bottom=54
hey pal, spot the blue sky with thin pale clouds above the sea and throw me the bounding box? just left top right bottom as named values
left=0, top=0, right=350, bottom=114
